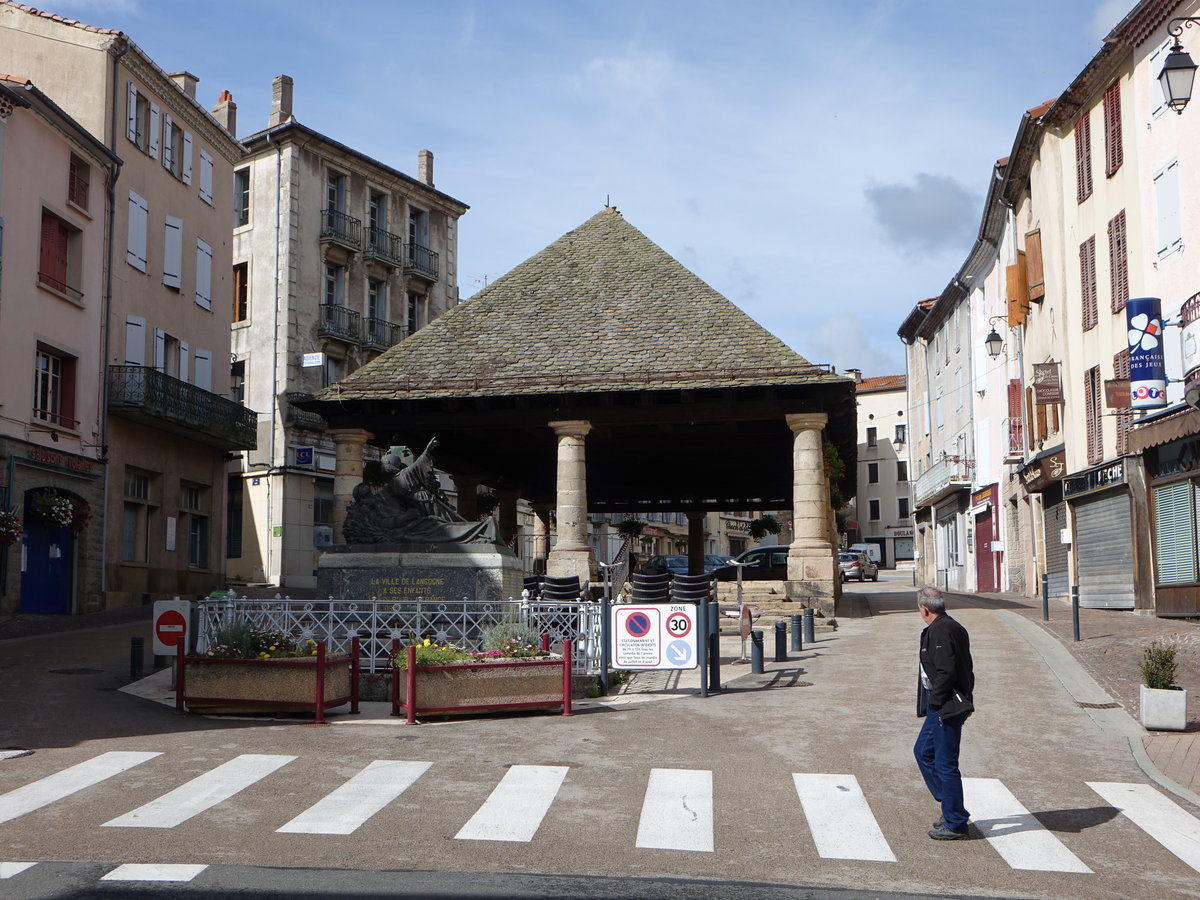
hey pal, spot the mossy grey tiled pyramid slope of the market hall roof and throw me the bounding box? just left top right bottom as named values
left=318, top=208, right=845, bottom=400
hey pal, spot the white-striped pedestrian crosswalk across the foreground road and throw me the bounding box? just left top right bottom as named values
left=0, top=751, right=1200, bottom=881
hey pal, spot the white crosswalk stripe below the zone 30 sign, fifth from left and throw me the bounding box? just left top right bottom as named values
left=636, top=769, right=713, bottom=853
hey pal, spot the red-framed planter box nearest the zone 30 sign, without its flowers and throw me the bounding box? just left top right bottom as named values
left=391, top=641, right=571, bottom=725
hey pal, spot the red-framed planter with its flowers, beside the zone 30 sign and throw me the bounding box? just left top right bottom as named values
left=391, top=623, right=571, bottom=724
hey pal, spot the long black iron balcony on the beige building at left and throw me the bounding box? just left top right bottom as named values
left=108, top=366, right=258, bottom=450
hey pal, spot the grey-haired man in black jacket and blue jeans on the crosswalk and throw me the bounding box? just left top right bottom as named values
left=912, top=588, right=974, bottom=841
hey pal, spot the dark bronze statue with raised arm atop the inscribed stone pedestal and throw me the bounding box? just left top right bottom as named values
left=342, top=438, right=496, bottom=544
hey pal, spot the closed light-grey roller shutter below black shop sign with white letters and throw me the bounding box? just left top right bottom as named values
left=1074, top=491, right=1134, bottom=610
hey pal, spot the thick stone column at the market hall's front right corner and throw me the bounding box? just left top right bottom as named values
left=786, top=413, right=841, bottom=617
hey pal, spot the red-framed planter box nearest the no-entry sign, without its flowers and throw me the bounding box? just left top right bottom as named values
left=175, top=641, right=359, bottom=722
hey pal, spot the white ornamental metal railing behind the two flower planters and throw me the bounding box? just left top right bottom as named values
left=197, top=595, right=601, bottom=674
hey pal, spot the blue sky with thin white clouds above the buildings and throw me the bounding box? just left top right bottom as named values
left=35, top=0, right=1134, bottom=377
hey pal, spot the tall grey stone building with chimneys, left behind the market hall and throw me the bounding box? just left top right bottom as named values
left=226, top=76, right=467, bottom=588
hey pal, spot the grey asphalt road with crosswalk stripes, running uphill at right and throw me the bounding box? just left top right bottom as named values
left=0, top=574, right=1200, bottom=900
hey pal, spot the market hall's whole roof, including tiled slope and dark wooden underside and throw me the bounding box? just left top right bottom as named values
left=301, top=206, right=856, bottom=514
